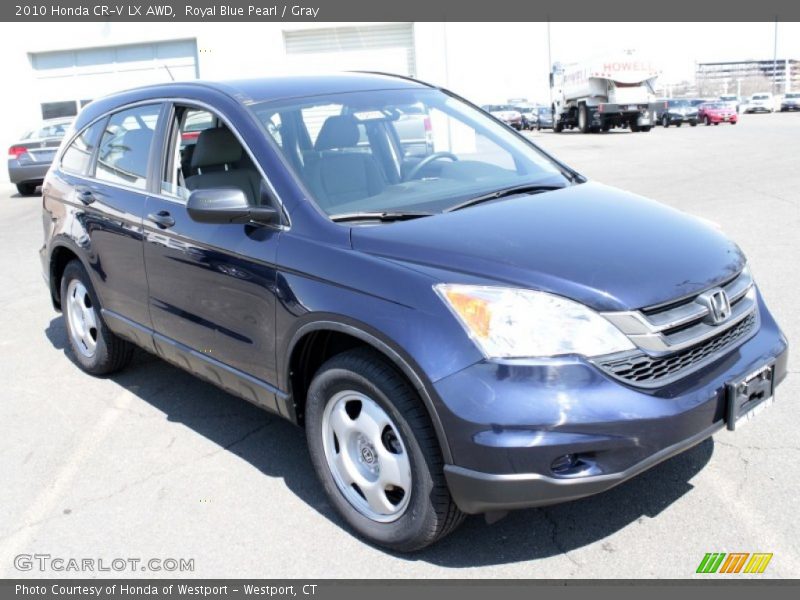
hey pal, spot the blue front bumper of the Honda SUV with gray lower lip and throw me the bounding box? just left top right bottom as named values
left=434, top=297, right=788, bottom=513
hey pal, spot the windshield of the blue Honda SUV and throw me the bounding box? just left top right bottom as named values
left=250, top=88, right=571, bottom=216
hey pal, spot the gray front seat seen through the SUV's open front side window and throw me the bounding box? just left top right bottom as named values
left=186, top=127, right=261, bottom=205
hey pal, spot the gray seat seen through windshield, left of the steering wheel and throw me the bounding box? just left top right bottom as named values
left=306, top=115, right=386, bottom=209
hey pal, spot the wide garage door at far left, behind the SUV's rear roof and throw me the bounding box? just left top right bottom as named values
left=30, top=40, right=197, bottom=119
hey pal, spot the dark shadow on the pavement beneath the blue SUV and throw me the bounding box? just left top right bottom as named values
left=45, top=317, right=714, bottom=576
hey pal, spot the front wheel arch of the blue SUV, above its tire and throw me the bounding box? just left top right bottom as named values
left=278, top=314, right=453, bottom=464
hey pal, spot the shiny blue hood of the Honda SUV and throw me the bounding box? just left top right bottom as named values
left=351, top=182, right=745, bottom=310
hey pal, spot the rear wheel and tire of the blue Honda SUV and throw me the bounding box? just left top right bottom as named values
left=61, top=260, right=134, bottom=375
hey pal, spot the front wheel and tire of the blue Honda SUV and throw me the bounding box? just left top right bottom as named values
left=306, top=349, right=465, bottom=552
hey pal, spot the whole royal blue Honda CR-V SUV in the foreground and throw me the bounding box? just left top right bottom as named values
left=40, top=73, right=787, bottom=551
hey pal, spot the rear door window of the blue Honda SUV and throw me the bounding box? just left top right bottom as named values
left=95, top=104, right=161, bottom=190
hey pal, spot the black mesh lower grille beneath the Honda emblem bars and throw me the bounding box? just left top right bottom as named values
left=600, top=312, right=757, bottom=386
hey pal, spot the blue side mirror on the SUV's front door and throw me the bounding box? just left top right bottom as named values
left=186, top=188, right=278, bottom=224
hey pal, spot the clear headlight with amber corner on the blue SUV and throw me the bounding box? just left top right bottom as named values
left=434, top=284, right=634, bottom=358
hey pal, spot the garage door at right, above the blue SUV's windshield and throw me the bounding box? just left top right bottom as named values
left=283, top=23, right=416, bottom=76
